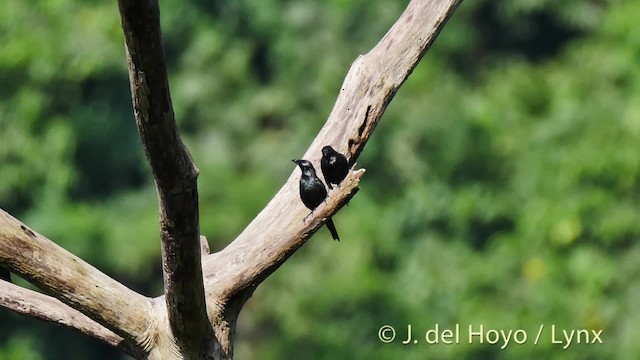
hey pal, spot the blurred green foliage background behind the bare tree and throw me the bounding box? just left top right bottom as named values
left=0, top=0, right=640, bottom=360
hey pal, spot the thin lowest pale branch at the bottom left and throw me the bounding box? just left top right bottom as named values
left=0, top=281, right=139, bottom=356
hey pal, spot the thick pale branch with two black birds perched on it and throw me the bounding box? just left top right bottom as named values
left=203, top=0, right=461, bottom=332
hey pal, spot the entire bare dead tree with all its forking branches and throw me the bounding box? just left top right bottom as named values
left=0, top=0, right=461, bottom=359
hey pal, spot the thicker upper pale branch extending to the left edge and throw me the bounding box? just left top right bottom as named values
left=0, top=209, right=152, bottom=352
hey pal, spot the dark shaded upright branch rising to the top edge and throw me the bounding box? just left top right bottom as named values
left=118, top=0, right=214, bottom=359
